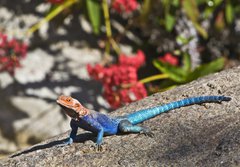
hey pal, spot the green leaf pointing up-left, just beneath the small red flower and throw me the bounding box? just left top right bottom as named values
left=153, top=60, right=186, bottom=83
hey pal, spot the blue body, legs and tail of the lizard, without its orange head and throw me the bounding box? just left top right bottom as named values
left=60, top=96, right=231, bottom=145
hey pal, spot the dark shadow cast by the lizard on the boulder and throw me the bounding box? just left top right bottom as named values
left=9, top=133, right=94, bottom=158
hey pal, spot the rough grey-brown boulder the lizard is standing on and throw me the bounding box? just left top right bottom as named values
left=0, top=67, right=240, bottom=166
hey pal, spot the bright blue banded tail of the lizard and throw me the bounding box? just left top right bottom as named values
left=125, top=96, right=231, bottom=125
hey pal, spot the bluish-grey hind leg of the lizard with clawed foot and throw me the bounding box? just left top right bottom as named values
left=119, top=120, right=154, bottom=137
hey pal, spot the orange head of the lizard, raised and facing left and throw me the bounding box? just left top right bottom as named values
left=57, top=95, right=89, bottom=120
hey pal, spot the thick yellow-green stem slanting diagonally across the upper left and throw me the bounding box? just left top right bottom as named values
left=26, top=0, right=78, bottom=35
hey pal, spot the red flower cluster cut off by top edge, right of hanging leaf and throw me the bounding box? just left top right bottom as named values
left=112, top=0, right=138, bottom=14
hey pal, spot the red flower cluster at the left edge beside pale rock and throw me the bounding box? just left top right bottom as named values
left=0, top=33, right=27, bottom=75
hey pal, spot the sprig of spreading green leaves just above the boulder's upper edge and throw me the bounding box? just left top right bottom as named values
left=153, top=53, right=224, bottom=84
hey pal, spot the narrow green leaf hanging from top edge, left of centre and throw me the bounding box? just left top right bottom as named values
left=86, top=0, right=101, bottom=34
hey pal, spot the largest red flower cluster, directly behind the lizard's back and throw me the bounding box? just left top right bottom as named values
left=87, top=50, right=147, bottom=108
